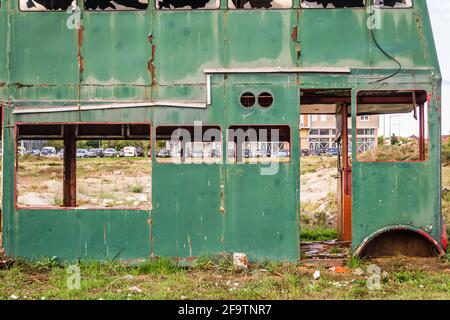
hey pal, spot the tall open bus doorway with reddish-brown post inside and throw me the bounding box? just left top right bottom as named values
left=300, top=89, right=352, bottom=259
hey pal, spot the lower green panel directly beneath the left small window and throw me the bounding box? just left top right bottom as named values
left=152, top=162, right=223, bottom=258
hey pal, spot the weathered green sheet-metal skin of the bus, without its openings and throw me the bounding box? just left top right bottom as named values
left=0, top=0, right=445, bottom=260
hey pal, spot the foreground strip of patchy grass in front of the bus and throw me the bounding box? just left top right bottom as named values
left=0, top=255, right=450, bottom=300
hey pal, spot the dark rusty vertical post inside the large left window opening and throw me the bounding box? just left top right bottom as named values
left=63, top=125, right=77, bottom=207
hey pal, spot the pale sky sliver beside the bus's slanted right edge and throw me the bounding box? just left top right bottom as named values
left=427, top=0, right=450, bottom=134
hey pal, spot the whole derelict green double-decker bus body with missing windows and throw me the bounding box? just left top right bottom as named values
left=0, top=0, right=446, bottom=261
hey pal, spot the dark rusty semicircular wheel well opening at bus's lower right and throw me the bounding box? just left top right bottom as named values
left=358, top=229, right=439, bottom=258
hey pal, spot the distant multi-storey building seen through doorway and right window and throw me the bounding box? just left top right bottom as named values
left=300, top=115, right=380, bottom=152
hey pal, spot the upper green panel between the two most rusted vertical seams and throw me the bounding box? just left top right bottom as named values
left=80, top=11, right=151, bottom=86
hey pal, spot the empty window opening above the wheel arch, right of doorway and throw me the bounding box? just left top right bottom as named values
left=356, top=91, right=428, bottom=162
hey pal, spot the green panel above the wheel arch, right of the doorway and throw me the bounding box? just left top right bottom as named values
left=352, top=87, right=445, bottom=250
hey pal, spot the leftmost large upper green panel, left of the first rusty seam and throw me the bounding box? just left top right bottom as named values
left=9, top=8, right=79, bottom=86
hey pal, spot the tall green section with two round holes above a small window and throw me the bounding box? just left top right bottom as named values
left=223, top=75, right=299, bottom=261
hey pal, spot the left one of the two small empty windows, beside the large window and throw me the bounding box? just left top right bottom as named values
left=154, top=124, right=222, bottom=164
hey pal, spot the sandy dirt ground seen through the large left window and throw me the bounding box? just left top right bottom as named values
left=17, top=158, right=151, bottom=209
